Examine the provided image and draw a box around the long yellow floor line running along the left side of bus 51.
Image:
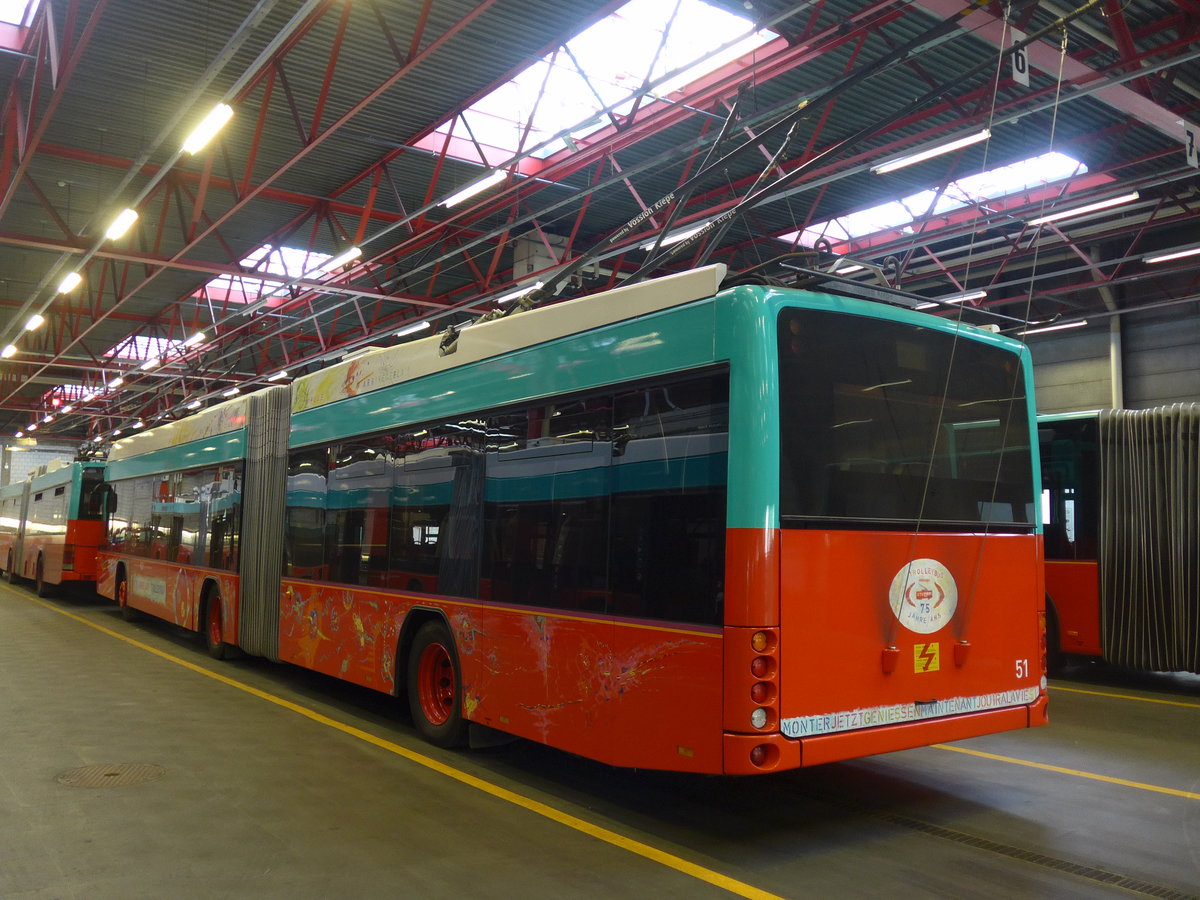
[23,592,782,900]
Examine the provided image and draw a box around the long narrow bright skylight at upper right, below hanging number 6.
[779,152,1087,253]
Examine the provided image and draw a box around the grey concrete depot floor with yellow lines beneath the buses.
[0,586,1200,900]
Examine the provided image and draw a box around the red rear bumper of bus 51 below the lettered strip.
[725,694,1049,775]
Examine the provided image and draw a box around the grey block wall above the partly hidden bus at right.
[1030,316,1200,413]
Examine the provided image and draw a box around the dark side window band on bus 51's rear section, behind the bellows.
[287,373,728,623]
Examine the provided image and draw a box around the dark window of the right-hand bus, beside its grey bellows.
[1038,419,1099,559]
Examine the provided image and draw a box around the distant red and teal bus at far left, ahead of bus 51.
[0,461,104,596]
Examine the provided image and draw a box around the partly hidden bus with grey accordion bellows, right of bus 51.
[1038,403,1200,673]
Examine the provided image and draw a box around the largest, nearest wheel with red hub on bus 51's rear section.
[407,619,467,748]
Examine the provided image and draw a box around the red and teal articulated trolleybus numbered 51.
[100,266,1046,773]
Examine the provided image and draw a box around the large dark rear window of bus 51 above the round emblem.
[779,310,1036,532]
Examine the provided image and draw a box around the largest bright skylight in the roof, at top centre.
[420,0,775,166]
